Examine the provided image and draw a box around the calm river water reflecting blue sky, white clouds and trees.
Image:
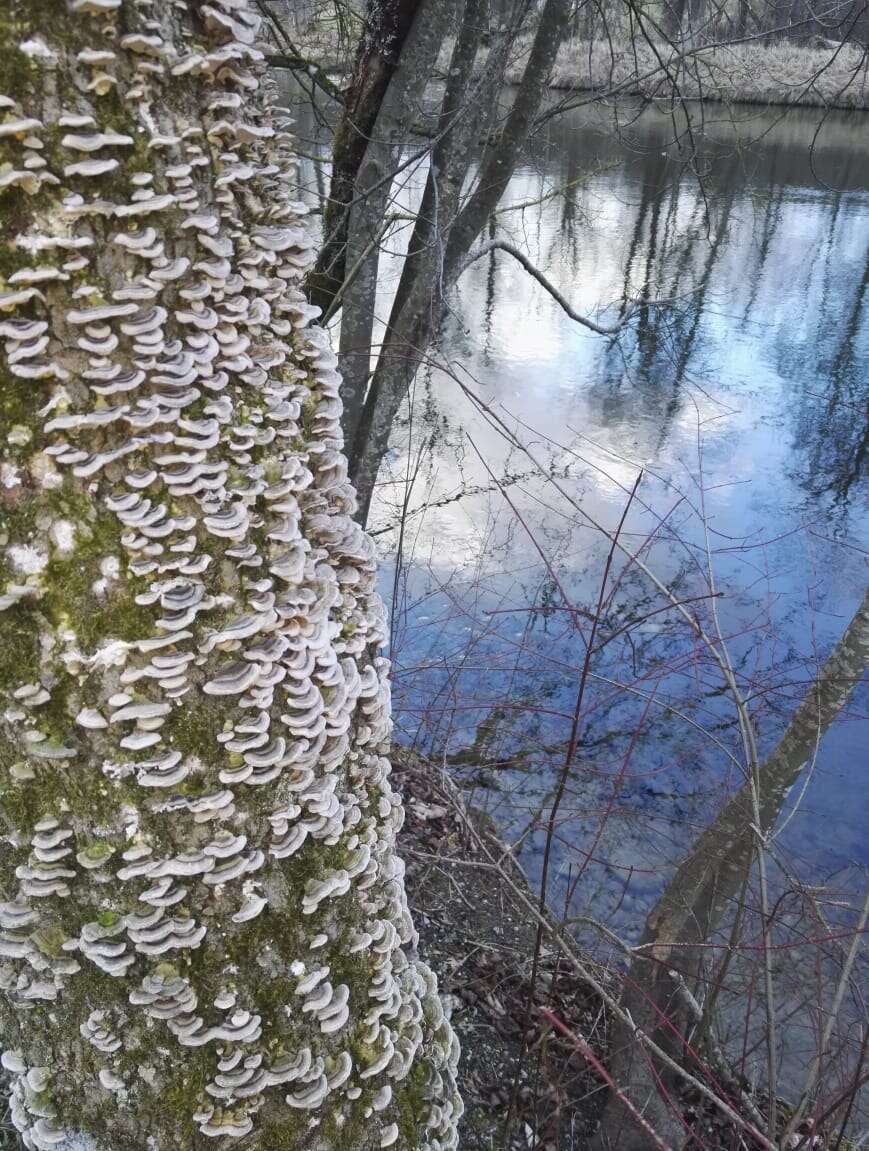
[281,78,869,1068]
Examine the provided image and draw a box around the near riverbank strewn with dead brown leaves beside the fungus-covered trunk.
[392,747,610,1151]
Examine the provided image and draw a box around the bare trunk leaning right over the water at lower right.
[596,592,869,1151]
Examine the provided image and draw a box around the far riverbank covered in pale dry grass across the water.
[269,37,869,110]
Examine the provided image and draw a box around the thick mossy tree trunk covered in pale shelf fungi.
[0,0,460,1151]
